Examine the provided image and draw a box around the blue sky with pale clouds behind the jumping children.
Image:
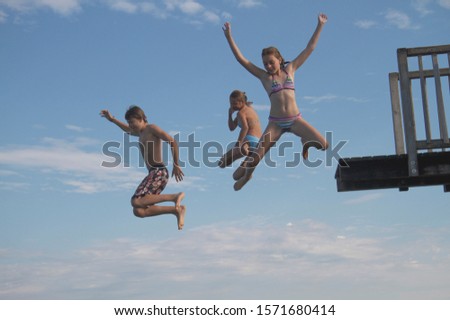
[0,0,450,299]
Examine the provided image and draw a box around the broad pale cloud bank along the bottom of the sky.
[0,220,450,299]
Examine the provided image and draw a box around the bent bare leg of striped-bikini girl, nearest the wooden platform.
[291,118,328,160]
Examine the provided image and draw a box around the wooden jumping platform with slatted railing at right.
[335,45,450,192]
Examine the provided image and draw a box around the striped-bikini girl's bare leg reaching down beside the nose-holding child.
[233,122,283,191]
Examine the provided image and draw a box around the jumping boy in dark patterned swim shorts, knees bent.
[100,106,186,230]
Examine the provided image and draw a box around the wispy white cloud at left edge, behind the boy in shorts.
[0,137,205,193]
